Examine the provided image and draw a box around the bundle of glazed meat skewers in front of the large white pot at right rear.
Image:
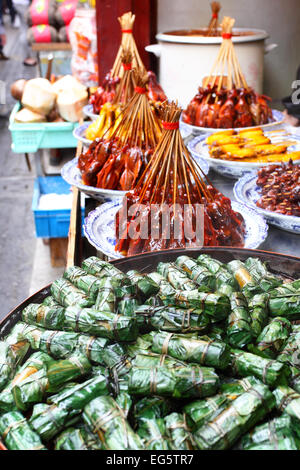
[183,16,274,129]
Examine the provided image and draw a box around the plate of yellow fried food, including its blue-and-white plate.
[188,128,300,179]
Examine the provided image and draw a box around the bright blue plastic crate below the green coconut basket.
[32,176,84,238]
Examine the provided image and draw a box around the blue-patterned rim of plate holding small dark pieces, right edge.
[233,171,300,224]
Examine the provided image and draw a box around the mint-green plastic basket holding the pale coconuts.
[8,103,78,153]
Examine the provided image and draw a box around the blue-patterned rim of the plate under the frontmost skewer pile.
[83,198,268,258]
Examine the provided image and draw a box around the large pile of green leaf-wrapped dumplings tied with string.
[0,254,300,450]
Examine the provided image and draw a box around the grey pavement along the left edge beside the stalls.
[0,6,62,319]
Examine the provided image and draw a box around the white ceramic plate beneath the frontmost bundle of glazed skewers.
[83,199,268,259]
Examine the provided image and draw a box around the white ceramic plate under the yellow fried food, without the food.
[187,134,300,179]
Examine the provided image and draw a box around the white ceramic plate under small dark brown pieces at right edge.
[233,172,300,234]
